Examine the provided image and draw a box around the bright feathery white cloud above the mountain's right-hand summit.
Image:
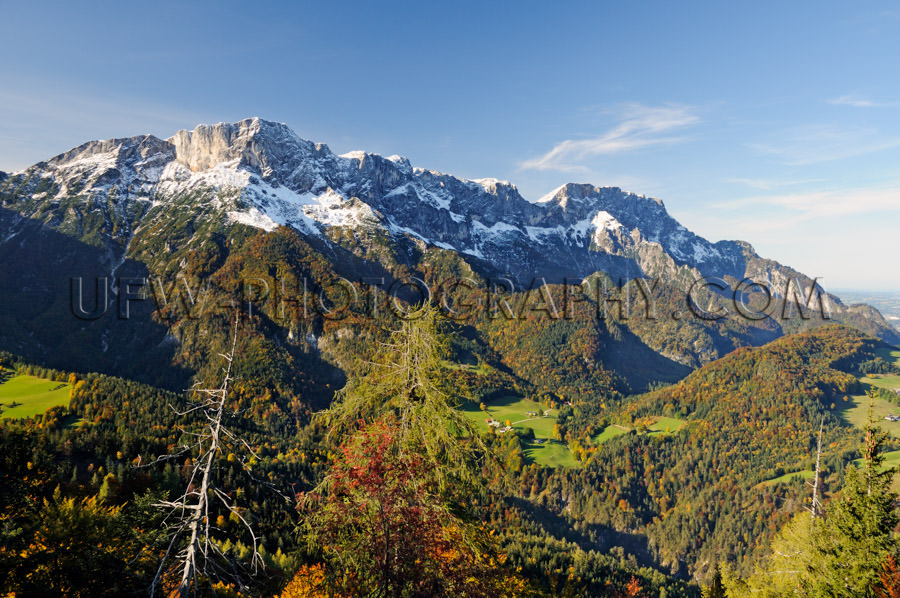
[519,104,700,172]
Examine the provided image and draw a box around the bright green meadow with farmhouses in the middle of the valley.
[463,397,578,467]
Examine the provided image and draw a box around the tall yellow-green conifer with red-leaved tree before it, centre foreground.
[301,306,525,596]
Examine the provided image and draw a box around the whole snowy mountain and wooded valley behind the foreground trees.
[0,118,900,597]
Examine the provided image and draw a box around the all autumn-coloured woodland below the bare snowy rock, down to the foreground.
[0,191,900,598]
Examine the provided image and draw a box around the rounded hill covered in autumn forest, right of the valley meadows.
[538,326,896,578]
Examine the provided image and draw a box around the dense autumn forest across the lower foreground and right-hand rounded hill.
[0,309,897,596]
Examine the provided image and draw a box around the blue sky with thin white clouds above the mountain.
[0,1,900,291]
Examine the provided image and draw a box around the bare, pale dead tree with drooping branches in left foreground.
[150,319,263,598]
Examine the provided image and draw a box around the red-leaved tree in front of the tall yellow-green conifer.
[308,418,458,596]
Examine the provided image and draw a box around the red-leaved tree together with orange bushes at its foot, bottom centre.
[298,416,527,597]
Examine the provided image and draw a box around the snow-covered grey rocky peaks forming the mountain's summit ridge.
[0,118,796,288]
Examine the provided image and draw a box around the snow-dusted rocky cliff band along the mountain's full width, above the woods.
[0,118,889,342]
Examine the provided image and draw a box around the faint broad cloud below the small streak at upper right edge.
[748,125,900,166]
